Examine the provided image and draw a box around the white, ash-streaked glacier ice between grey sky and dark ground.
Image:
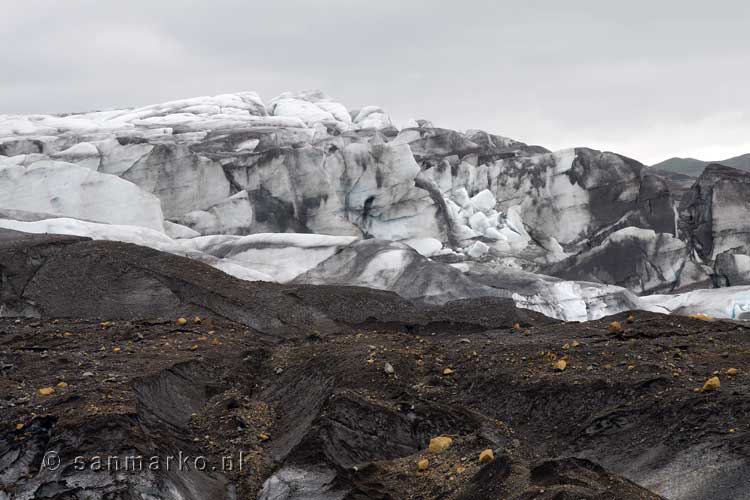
[0,91,750,321]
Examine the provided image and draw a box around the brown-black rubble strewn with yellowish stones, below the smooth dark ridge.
[5,306,750,500]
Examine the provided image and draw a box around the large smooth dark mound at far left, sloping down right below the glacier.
[0,232,325,333]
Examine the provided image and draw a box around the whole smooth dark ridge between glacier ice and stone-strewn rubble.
[0,231,547,335]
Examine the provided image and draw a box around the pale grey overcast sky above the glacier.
[0,0,750,163]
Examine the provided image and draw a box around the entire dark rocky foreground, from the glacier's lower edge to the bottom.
[0,232,750,500]
